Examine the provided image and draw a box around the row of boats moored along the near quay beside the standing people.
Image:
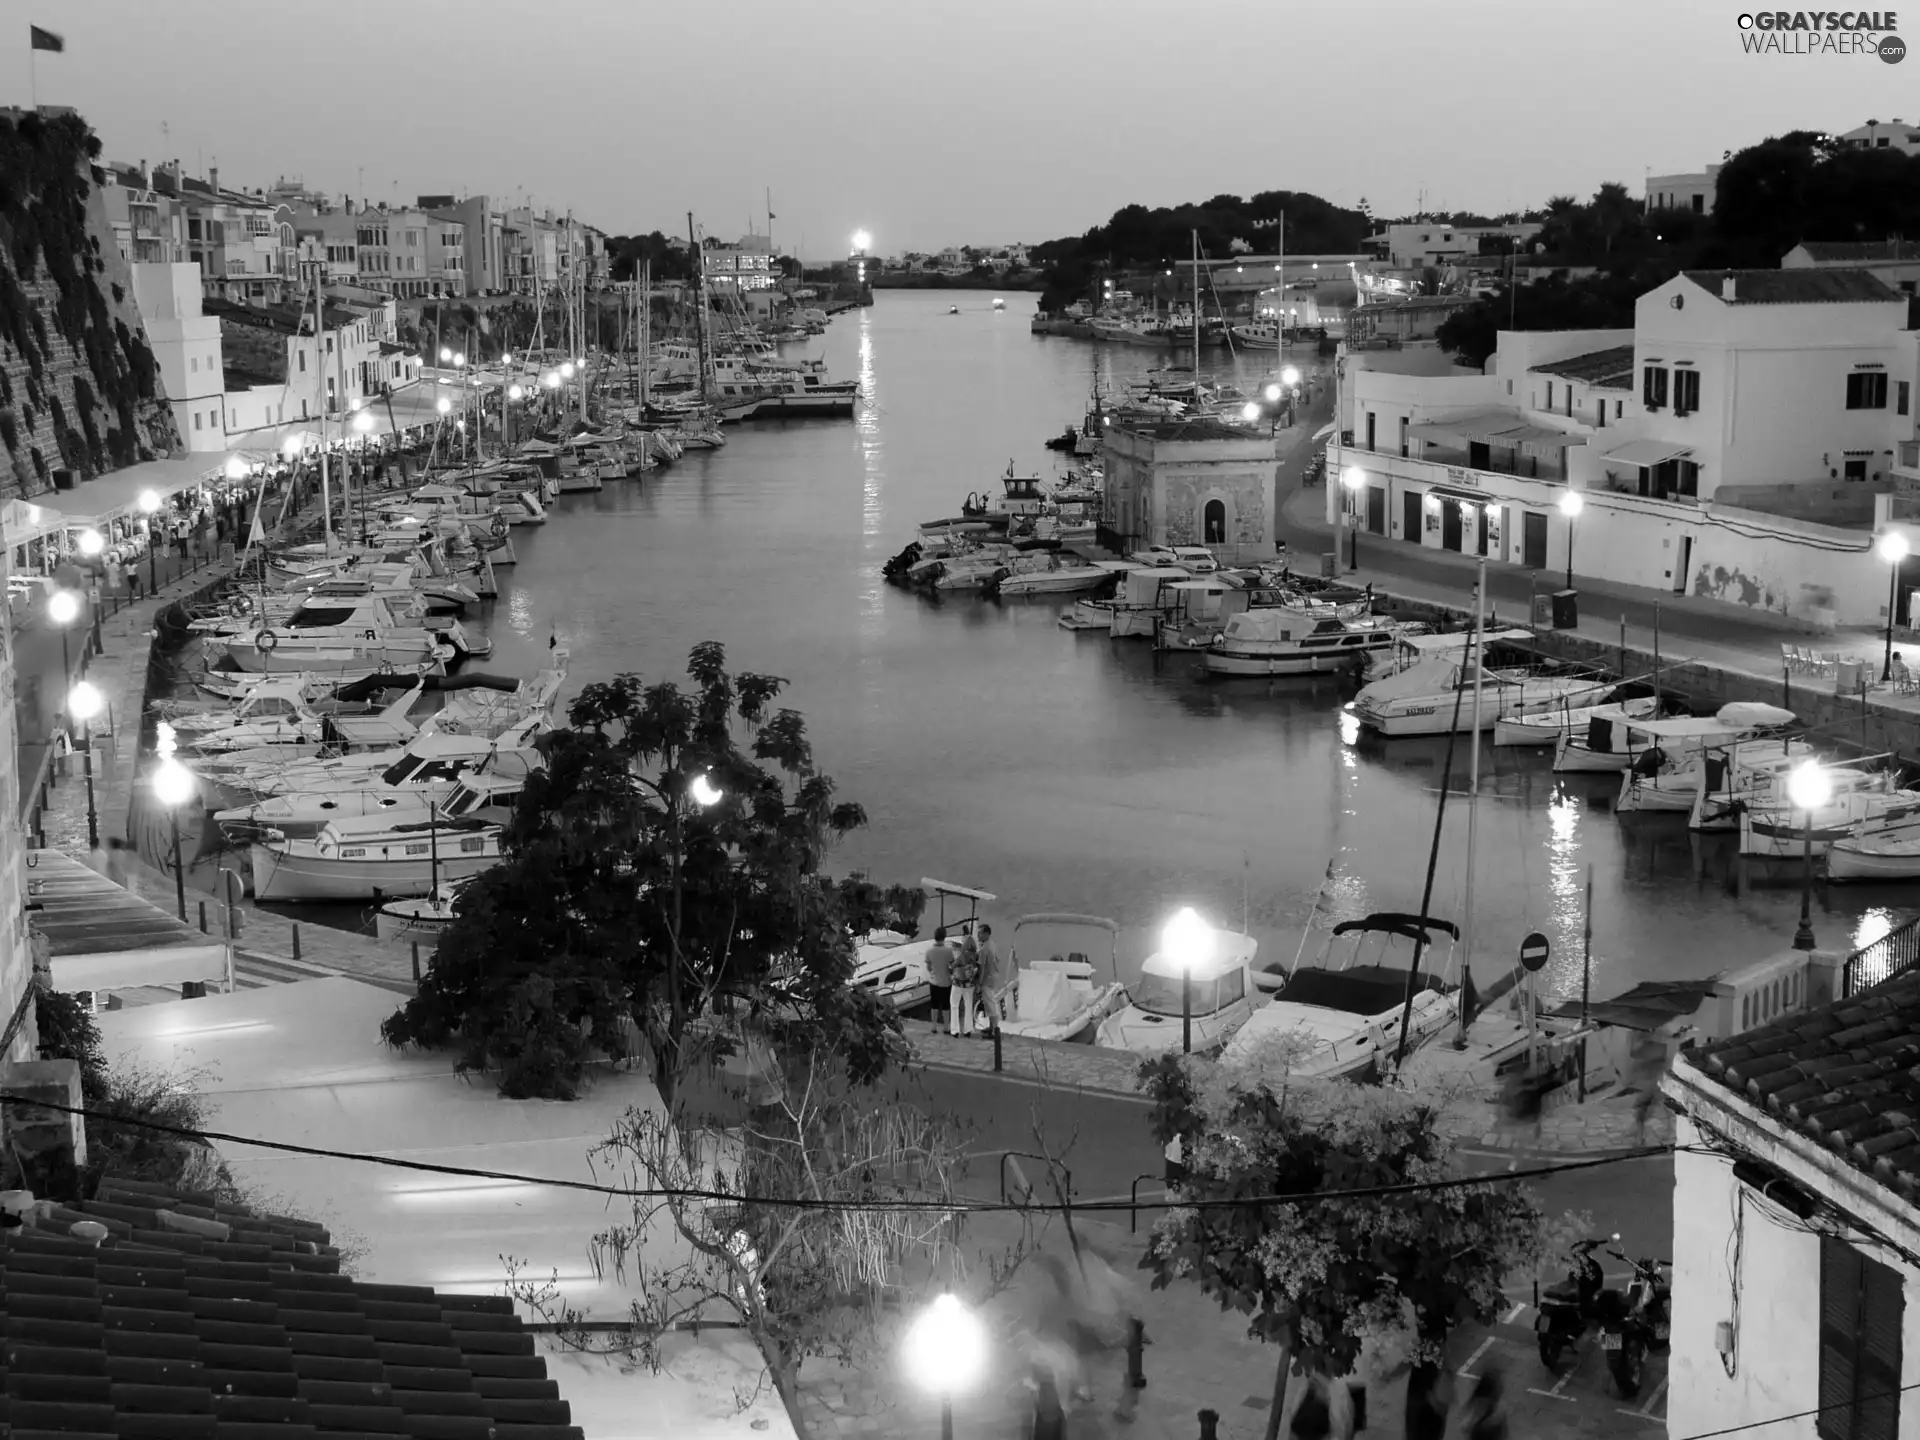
[854,879,1463,1079]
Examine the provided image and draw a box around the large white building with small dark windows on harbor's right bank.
[1327,269,1920,624]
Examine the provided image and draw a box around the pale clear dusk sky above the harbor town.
[15,0,1920,259]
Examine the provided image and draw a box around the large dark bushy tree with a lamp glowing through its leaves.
[382,641,900,1108]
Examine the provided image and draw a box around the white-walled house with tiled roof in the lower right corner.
[1661,952,1920,1440]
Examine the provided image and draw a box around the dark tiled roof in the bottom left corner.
[0,1181,582,1440]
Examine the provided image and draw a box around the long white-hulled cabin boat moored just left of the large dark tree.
[250,816,503,900]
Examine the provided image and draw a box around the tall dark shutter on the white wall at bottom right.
[1814,1236,1907,1440]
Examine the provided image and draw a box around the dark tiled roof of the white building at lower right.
[1693,970,1920,1202]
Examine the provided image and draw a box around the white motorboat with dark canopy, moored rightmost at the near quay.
[1221,914,1459,1079]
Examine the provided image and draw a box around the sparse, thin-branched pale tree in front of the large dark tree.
[509,1044,1025,1440]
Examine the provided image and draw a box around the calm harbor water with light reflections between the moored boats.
[274,292,1905,996]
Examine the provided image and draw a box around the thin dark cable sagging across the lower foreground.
[0,1092,1693,1215]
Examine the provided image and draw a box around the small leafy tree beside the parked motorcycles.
[1140,1056,1546,1440]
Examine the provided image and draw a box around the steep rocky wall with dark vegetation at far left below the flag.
[0,115,180,497]
